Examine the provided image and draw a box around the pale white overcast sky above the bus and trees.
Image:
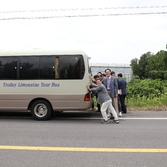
[0,0,167,64]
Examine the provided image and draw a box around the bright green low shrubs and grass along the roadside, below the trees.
[126,79,167,110]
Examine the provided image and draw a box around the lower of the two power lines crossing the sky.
[0,12,167,20]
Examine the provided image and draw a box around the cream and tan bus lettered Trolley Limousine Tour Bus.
[0,49,91,120]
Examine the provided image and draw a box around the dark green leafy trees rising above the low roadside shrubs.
[130,50,167,79]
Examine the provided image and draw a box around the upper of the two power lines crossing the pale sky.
[0,5,167,14]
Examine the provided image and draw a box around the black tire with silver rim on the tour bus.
[31,100,52,120]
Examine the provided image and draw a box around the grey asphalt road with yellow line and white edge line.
[0,111,167,167]
